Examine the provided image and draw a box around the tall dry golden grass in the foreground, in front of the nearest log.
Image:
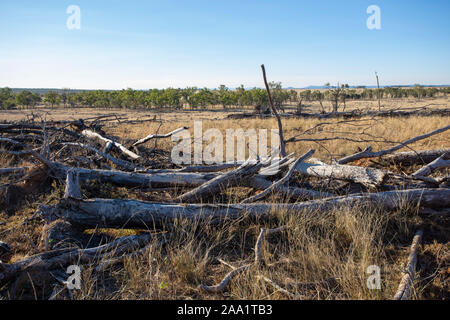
[67,202,428,299]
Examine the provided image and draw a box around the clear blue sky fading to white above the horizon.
[0,0,450,89]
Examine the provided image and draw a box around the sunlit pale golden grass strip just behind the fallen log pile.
[109,116,450,160]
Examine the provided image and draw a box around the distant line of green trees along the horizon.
[0,82,450,112]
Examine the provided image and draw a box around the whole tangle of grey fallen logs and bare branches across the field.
[0,110,450,298]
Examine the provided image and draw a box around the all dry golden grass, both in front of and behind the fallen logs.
[0,103,450,299]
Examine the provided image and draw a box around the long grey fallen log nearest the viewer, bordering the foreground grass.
[48,189,450,229]
